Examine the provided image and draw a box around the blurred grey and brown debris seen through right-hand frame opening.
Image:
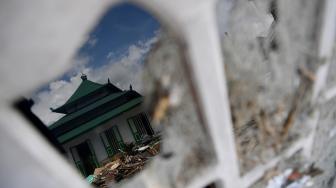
[218,0,322,173]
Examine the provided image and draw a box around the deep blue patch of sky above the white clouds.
[78,4,160,72]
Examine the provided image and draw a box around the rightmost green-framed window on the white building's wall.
[127,113,154,142]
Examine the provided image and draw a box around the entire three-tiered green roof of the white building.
[49,76,143,143]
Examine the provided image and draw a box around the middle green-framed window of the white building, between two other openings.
[100,125,125,157]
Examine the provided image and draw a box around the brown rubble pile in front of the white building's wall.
[87,138,160,187]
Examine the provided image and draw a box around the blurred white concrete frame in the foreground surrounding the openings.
[0,0,336,188]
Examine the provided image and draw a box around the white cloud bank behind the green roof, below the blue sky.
[32,36,157,125]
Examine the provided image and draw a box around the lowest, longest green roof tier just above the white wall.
[57,97,143,144]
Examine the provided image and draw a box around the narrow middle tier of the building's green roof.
[49,91,127,129]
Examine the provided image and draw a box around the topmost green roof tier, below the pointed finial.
[63,80,104,106]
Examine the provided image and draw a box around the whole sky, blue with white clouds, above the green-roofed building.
[32,4,160,125]
